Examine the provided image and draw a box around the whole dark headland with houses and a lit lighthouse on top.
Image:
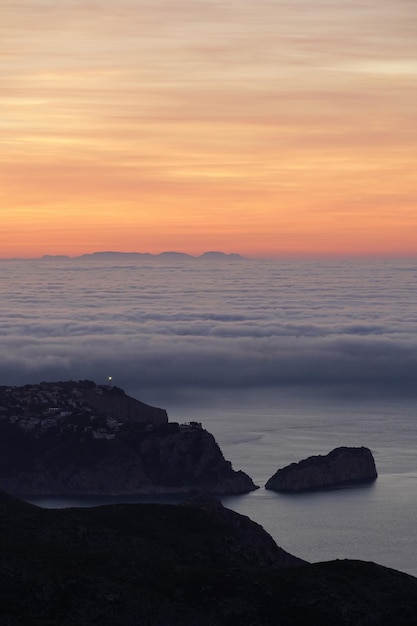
[0,380,257,497]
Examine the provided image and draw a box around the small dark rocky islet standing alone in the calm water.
[265,447,377,492]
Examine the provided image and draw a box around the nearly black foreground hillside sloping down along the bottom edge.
[0,495,417,626]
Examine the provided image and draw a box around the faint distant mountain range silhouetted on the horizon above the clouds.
[37,250,247,261]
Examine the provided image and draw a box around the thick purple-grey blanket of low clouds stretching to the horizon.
[0,255,417,398]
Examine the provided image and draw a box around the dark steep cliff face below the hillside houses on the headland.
[0,424,256,496]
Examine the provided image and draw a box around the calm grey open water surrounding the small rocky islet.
[169,389,417,575]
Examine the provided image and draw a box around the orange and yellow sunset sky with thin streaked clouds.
[0,0,417,258]
